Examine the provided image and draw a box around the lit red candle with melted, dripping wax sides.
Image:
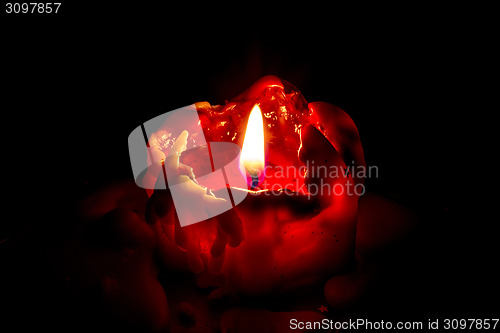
[140,76,364,296]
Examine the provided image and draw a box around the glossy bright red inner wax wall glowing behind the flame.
[193,76,309,192]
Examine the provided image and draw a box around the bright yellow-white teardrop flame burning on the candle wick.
[240,104,265,187]
